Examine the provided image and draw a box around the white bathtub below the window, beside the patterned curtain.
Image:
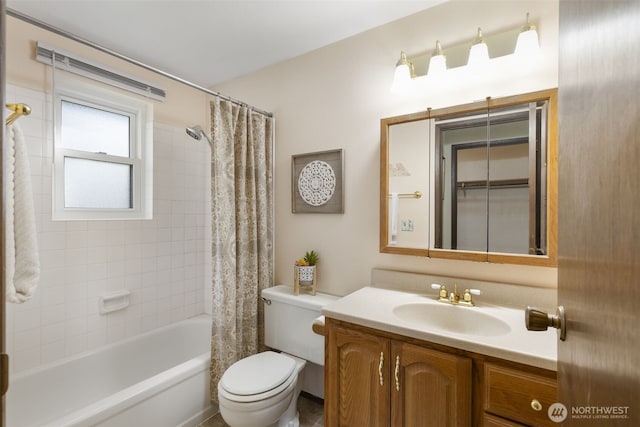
[6,316,217,427]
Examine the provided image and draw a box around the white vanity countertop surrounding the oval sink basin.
[322,287,558,371]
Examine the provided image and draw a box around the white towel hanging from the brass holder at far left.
[4,123,40,303]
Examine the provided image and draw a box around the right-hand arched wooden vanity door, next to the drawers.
[391,341,471,427]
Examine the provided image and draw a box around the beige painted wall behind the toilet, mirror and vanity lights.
[215,1,558,295]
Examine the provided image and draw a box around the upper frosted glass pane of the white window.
[61,101,130,157]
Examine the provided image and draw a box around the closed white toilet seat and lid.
[218,351,297,402]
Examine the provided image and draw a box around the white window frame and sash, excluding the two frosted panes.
[52,78,153,221]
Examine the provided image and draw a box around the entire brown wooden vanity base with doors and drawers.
[325,318,557,427]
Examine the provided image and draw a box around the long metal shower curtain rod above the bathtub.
[7,8,273,117]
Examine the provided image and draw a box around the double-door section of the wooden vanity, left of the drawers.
[325,321,472,427]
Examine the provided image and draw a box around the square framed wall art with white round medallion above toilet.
[291,149,344,213]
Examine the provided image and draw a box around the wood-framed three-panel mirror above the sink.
[380,90,557,266]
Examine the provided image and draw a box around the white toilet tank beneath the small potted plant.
[262,285,338,365]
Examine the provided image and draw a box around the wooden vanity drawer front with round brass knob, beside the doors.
[484,363,558,427]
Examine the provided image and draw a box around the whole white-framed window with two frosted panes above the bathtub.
[53,80,153,220]
